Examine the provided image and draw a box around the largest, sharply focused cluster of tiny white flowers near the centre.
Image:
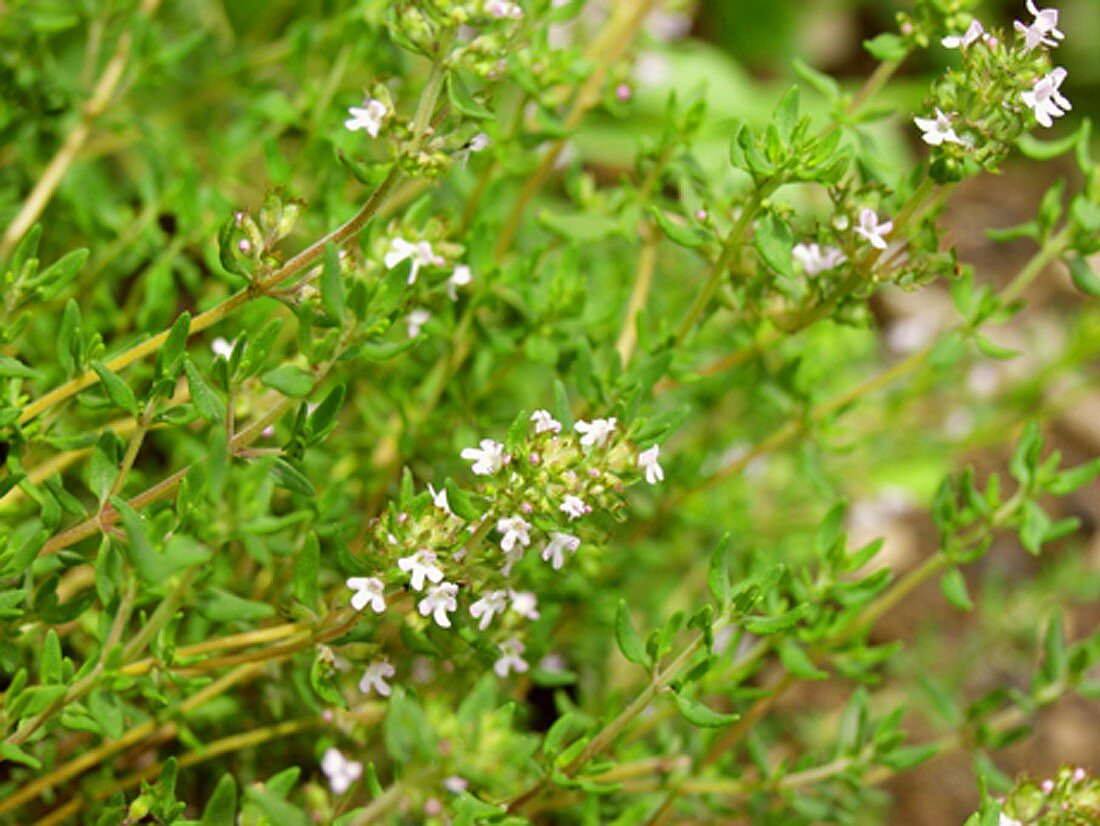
[330,411,664,695]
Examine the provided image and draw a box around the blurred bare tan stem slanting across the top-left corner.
[0,0,161,257]
